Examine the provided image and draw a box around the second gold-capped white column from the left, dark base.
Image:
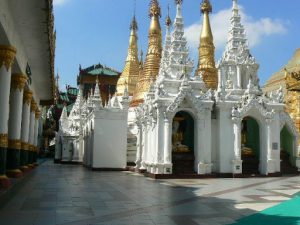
[6,74,27,178]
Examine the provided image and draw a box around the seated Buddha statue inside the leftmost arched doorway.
[172,117,190,153]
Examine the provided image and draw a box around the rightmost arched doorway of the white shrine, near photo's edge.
[280,126,298,174]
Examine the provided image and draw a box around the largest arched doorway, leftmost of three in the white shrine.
[172,111,195,174]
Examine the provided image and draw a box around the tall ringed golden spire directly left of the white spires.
[131,0,162,107]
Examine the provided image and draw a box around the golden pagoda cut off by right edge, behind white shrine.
[263,48,300,145]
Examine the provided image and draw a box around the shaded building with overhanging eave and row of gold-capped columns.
[0,0,55,188]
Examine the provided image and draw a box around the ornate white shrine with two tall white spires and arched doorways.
[136,1,300,175]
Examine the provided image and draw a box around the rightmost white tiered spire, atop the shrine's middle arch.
[218,0,259,92]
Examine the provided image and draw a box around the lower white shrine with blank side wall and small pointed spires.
[55,81,129,170]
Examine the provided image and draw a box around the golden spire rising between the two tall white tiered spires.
[197,0,218,89]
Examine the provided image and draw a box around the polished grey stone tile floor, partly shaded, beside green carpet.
[0,161,300,225]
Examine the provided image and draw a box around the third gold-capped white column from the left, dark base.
[20,90,32,171]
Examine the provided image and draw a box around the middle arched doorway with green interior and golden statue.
[241,117,260,174]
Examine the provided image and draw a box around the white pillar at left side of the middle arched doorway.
[232,118,243,174]
